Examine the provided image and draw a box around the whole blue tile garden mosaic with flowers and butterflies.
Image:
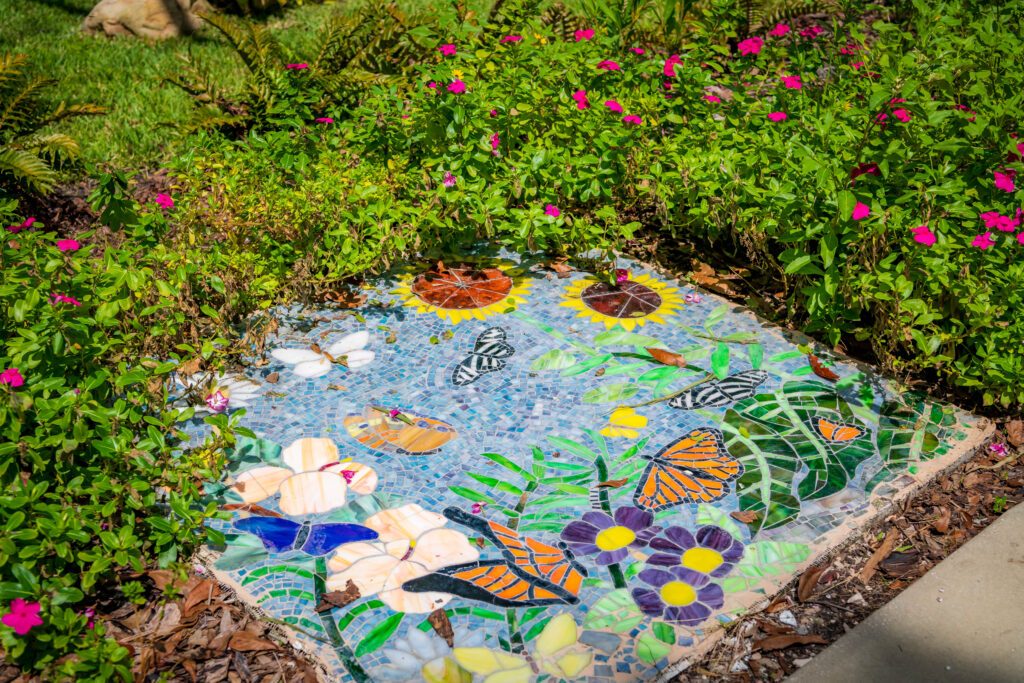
[180,255,981,683]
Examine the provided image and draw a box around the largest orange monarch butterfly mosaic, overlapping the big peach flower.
[401,508,587,607]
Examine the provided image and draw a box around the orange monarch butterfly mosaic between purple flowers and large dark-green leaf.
[633,427,743,512]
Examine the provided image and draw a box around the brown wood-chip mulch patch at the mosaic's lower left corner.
[0,570,323,683]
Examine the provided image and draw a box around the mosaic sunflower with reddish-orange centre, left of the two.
[391,261,529,325]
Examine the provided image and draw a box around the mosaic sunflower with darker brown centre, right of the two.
[559,273,683,331]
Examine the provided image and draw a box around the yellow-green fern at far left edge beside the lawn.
[0,52,103,194]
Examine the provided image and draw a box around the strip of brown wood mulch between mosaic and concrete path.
[675,419,1024,683]
